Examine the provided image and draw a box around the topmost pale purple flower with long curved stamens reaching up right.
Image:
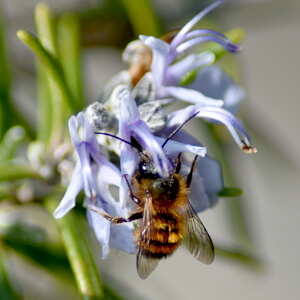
[140,1,240,106]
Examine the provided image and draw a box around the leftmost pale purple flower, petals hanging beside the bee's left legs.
[54,113,135,258]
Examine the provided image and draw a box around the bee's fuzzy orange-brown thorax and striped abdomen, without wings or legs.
[132,174,188,259]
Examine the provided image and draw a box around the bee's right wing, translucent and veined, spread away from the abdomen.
[186,201,215,265]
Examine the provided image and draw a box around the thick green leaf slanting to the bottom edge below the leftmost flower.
[45,197,105,299]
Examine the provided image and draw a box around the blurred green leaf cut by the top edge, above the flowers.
[123,0,162,36]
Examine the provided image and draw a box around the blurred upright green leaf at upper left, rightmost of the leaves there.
[57,13,84,111]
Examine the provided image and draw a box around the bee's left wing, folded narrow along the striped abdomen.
[136,197,159,279]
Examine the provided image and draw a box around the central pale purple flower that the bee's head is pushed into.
[115,88,224,212]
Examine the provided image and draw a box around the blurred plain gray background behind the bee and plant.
[2,0,300,300]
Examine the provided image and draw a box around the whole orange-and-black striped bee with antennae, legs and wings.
[95,113,214,279]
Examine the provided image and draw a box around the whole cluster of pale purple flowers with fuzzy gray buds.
[54,0,256,258]
